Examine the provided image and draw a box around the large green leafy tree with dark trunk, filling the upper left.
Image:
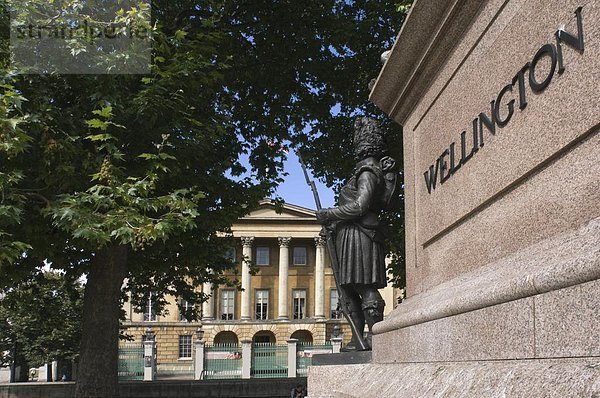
[0,0,402,397]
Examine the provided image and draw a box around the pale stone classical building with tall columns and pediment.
[125,200,394,366]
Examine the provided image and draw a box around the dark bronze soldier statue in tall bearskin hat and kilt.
[317,117,397,351]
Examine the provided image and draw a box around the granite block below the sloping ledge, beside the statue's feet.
[373,298,536,363]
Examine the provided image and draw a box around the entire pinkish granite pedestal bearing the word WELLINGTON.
[309,0,600,398]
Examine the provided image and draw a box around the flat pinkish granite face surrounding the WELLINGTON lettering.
[407,1,600,290]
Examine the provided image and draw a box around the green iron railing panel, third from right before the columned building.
[204,344,242,380]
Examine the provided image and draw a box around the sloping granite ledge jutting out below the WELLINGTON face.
[373,217,600,334]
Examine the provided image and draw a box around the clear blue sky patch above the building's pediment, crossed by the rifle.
[277,151,334,209]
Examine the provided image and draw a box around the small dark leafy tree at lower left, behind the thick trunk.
[0,272,83,380]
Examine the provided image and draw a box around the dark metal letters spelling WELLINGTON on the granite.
[424,7,583,194]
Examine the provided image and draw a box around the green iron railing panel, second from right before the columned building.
[250,343,288,378]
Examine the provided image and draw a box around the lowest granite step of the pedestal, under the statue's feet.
[308,358,600,398]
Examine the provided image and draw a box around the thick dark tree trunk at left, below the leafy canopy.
[75,246,127,398]
